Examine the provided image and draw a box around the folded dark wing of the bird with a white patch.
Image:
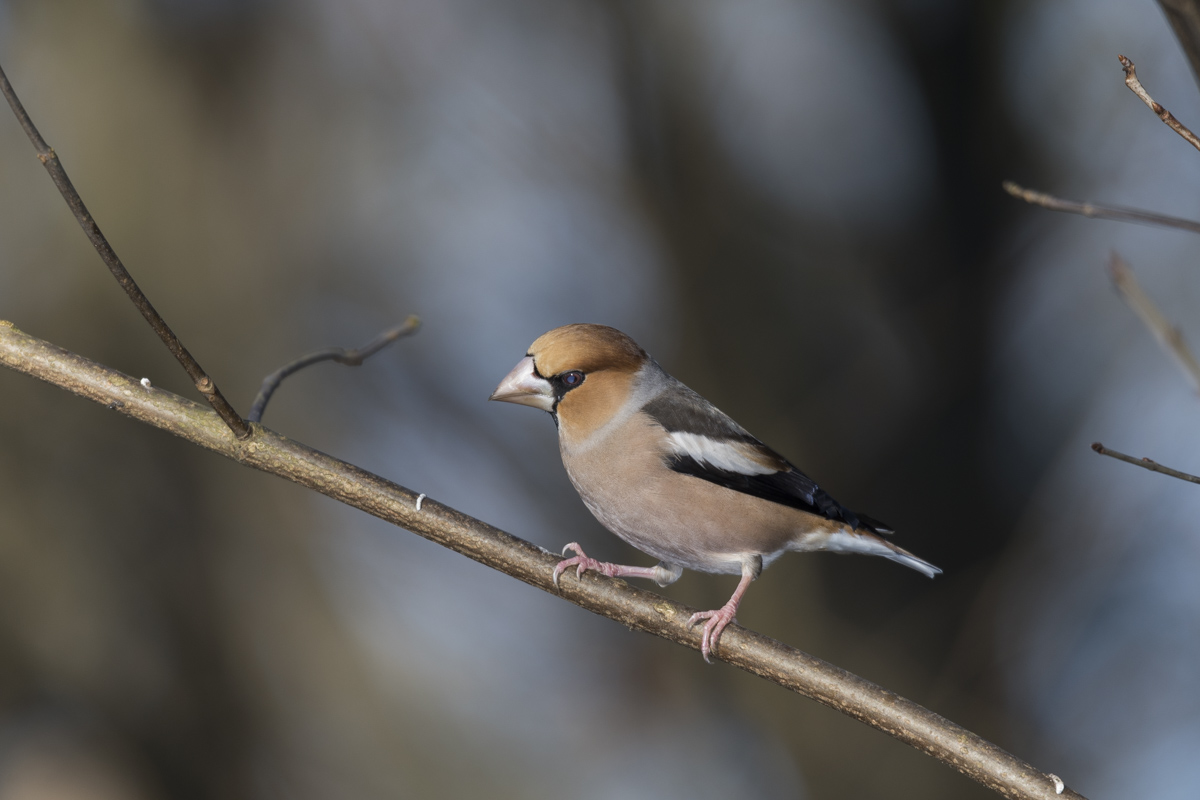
[643,381,892,534]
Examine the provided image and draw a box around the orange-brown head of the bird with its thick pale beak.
[488,324,649,433]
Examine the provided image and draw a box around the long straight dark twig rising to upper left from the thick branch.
[0,60,250,439]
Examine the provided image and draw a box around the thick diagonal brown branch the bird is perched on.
[0,321,1082,800]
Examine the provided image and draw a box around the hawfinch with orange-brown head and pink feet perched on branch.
[488,323,941,663]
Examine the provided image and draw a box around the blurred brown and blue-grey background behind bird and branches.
[0,0,1200,800]
